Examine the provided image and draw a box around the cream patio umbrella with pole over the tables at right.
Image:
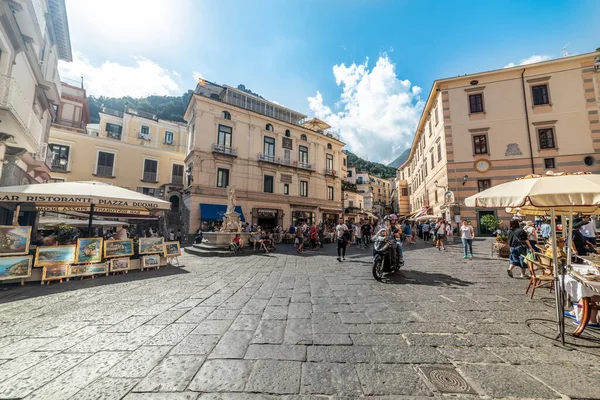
[465,172,600,345]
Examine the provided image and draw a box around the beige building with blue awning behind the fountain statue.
[184,83,346,233]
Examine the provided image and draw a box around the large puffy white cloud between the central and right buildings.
[308,54,424,163]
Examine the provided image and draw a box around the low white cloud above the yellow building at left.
[58,52,182,97]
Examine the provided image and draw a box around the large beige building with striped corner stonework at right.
[397,52,600,233]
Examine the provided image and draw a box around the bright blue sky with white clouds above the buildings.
[59,0,600,163]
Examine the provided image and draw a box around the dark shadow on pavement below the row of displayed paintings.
[0,265,189,304]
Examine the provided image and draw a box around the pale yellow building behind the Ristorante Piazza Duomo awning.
[48,83,187,229]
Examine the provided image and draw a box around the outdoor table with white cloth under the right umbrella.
[565,265,600,336]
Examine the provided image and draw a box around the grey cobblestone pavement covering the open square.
[0,240,600,400]
